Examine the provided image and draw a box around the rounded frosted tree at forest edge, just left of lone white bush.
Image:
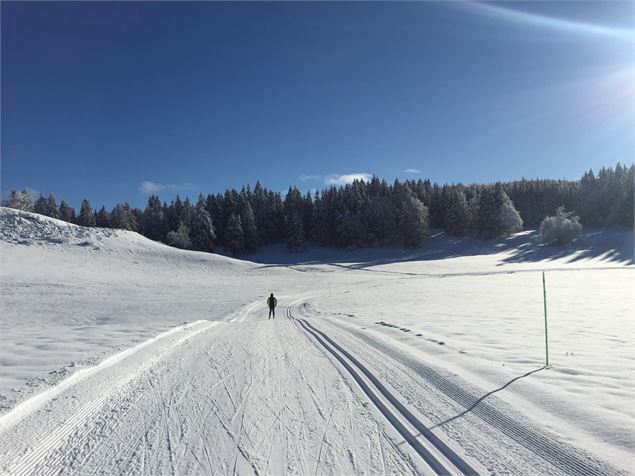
[478,183,523,238]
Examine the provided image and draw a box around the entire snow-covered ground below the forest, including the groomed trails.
[0,208,635,475]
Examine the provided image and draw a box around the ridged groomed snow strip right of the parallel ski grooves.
[288,298,626,476]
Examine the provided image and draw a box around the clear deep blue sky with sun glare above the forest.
[1,1,635,207]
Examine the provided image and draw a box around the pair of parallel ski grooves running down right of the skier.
[286,303,478,475]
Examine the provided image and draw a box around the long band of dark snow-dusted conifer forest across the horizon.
[4,163,635,256]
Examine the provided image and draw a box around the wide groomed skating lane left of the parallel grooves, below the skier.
[0,303,426,475]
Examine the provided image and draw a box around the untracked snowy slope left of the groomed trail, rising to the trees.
[0,207,296,411]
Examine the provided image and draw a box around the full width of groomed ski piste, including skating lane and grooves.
[0,297,620,475]
